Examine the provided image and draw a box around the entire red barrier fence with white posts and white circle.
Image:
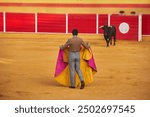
[0,12,150,41]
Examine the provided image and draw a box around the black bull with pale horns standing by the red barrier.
[100,25,116,47]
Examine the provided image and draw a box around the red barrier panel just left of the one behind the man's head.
[38,13,66,33]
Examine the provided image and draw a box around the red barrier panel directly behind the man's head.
[68,14,96,33]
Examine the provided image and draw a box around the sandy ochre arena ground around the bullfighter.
[0,34,150,100]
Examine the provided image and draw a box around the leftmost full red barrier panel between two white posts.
[6,13,35,32]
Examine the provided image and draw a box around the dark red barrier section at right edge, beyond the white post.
[142,14,150,35]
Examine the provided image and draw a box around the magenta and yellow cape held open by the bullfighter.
[54,48,97,87]
